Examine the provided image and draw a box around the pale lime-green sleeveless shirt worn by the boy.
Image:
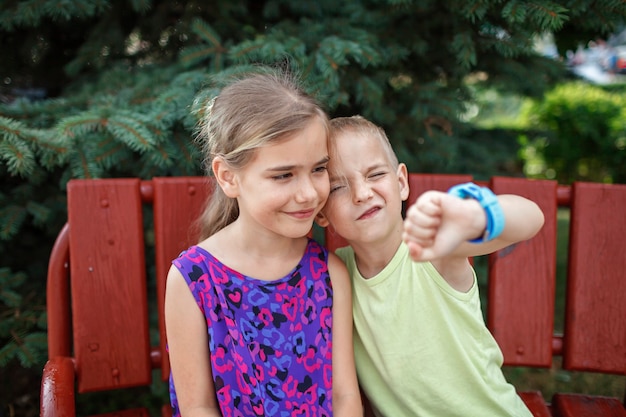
[337,243,532,417]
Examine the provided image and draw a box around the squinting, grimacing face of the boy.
[317,131,409,244]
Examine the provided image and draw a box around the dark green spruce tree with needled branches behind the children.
[0,0,626,415]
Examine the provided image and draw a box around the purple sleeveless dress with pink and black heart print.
[170,240,333,417]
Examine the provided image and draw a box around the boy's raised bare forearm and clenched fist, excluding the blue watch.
[403,191,544,261]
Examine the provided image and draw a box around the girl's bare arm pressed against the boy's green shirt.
[328,253,363,417]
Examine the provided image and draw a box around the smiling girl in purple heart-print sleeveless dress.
[165,72,362,417]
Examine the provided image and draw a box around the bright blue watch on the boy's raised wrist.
[448,182,505,243]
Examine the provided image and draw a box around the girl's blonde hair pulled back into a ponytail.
[197,70,329,240]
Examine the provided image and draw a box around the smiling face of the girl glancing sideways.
[229,118,330,238]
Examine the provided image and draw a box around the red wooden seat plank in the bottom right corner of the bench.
[552,394,626,417]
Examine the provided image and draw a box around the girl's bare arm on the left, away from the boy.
[165,266,221,417]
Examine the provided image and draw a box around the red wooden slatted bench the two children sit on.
[41,174,626,417]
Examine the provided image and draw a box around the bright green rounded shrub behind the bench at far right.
[521,82,626,184]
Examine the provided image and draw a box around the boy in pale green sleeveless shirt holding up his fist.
[317,116,544,417]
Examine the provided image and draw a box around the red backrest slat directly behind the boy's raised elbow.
[487,177,557,367]
